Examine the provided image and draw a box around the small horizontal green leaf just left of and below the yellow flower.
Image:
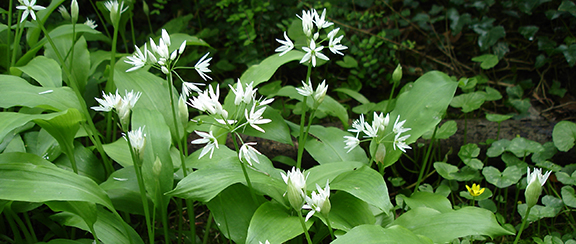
[397,191,452,213]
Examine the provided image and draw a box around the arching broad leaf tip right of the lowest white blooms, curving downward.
[330,166,393,213]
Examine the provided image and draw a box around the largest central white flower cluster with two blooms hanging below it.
[186,79,274,162]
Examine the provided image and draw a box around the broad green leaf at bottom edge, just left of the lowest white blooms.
[246,202,313,244]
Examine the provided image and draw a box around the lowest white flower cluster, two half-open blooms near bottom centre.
[281,168,331,221]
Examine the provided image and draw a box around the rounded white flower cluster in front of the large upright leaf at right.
[344,112,412,152]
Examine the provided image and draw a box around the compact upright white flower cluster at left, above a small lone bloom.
[92,90,142,129]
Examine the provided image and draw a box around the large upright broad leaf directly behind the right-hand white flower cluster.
[383,71,458,167]
